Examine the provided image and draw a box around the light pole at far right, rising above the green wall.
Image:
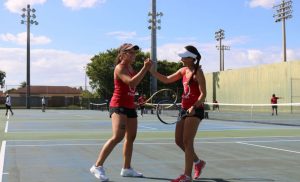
[273,0,293,62]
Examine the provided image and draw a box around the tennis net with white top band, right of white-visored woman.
[205,103,300,126]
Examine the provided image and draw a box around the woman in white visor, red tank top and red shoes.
[150,45,206,182]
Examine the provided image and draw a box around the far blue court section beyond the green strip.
[4,110,300,132]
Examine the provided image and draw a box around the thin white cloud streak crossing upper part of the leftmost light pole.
[0,32,51,45]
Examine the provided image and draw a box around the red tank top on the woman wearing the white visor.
[181,68,203,109]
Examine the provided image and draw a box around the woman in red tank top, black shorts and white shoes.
[90,43,152,181]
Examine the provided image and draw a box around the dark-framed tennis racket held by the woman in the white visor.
[156,100,188,125]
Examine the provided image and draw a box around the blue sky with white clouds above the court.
[0,0,300,88]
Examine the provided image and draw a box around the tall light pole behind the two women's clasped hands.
[148,0,163,94]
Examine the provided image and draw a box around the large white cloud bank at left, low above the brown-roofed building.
[0,48,92,87]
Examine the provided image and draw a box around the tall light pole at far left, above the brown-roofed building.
[21,4,38,109]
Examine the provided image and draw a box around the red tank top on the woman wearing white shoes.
[109,66,135,109]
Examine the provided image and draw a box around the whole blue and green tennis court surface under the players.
[0,110,300,182]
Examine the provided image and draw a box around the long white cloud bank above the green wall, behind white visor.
[154,38,300,73]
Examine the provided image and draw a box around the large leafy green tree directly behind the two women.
[86,49,182,99]
